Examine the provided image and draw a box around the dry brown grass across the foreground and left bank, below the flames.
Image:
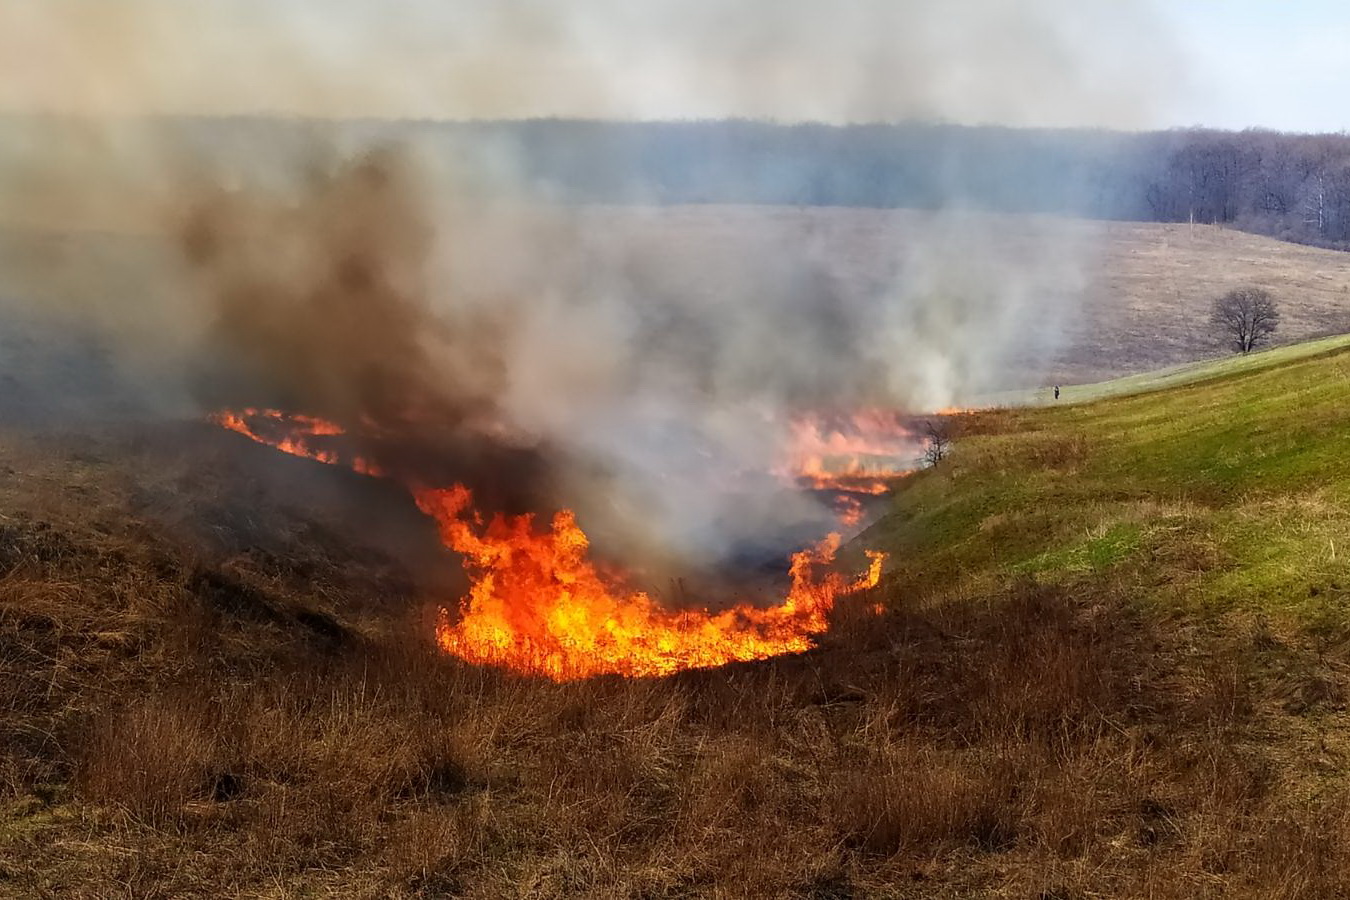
[0,426,1350,899]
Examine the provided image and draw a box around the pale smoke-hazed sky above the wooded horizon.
[0,0,1350,131]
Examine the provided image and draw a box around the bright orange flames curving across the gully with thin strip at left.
[212,410,886,681]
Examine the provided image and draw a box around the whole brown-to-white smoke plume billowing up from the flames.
[168,152,1081,565]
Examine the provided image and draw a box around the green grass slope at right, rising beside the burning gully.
[867,337,1350,625]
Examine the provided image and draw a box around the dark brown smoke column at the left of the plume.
[180,150,549,513]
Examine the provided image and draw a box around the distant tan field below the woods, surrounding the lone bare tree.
[569,206,1350,389]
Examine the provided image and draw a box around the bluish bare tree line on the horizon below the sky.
[431,119,1350,248]
